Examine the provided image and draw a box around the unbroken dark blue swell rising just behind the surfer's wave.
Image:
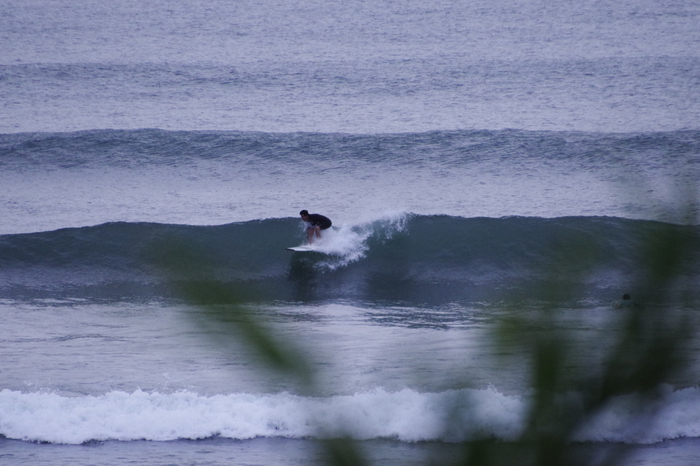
[0,129,700,171]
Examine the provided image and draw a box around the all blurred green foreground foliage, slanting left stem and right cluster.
[154,187,698,466]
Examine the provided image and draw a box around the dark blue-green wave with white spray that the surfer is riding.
[0,214,700,304]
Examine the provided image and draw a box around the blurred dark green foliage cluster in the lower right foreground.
[468,189,699,466]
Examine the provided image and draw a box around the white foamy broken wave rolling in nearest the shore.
[0,387,700,444]
